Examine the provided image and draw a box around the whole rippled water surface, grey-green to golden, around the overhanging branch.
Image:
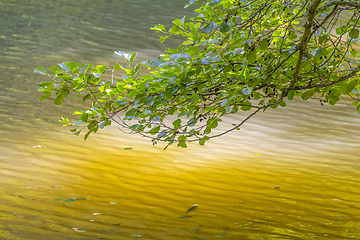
[0,0,360,239]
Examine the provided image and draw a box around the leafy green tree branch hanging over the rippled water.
[35,0,360,147]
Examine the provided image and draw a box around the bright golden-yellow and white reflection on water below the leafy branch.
[0,101,360,239]
